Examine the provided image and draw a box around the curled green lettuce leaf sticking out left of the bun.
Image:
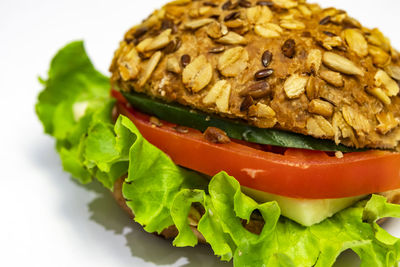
[36,42,128,189]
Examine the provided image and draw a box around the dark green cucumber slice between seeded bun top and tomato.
[122,92,363,152]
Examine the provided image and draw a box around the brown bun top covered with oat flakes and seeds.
[110,0,400,149]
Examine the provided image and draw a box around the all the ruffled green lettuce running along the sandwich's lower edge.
[36,42,400,267]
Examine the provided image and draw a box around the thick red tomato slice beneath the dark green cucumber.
[117,94,400,199]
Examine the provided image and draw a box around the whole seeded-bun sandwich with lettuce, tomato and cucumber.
[36,0,400,266]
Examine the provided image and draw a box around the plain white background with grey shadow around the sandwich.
[0,0,400,267]
